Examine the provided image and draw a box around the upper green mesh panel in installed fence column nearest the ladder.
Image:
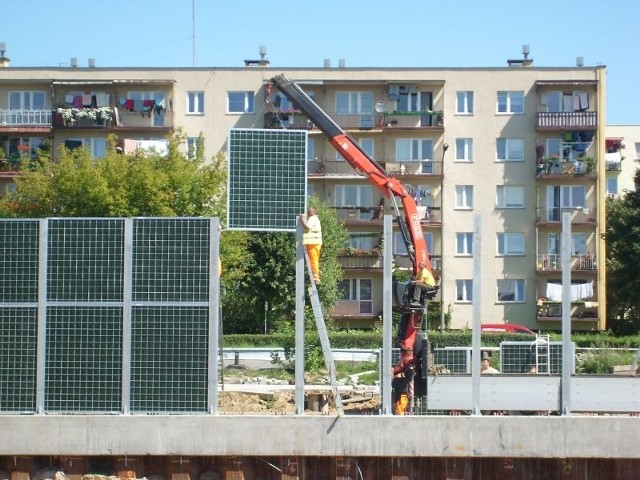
[132,218,210,302]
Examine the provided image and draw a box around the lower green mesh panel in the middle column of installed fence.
[45,307,122,412]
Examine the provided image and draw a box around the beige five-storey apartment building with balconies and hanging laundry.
[0,57,613,330]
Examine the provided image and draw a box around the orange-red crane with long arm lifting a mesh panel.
[266,75,437,414]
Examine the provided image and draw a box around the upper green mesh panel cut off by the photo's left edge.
[0,220,40,303]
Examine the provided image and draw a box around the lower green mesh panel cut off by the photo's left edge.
[0,307,38,412]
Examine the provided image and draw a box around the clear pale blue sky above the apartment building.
[0,0,640,125]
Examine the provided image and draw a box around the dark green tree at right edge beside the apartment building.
[604,171,640,334]
